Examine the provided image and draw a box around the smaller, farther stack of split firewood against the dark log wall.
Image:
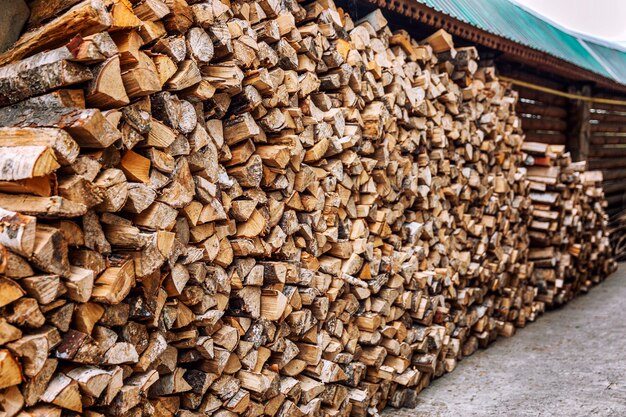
[523,142,615,305]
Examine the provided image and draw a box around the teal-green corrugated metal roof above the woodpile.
[417,0,626,85]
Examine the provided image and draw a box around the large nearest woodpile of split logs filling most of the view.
[0,0,616,417]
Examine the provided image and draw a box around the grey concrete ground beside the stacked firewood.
[385,263,626,417]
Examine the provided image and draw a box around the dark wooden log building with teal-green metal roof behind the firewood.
[342,0,626,217]
